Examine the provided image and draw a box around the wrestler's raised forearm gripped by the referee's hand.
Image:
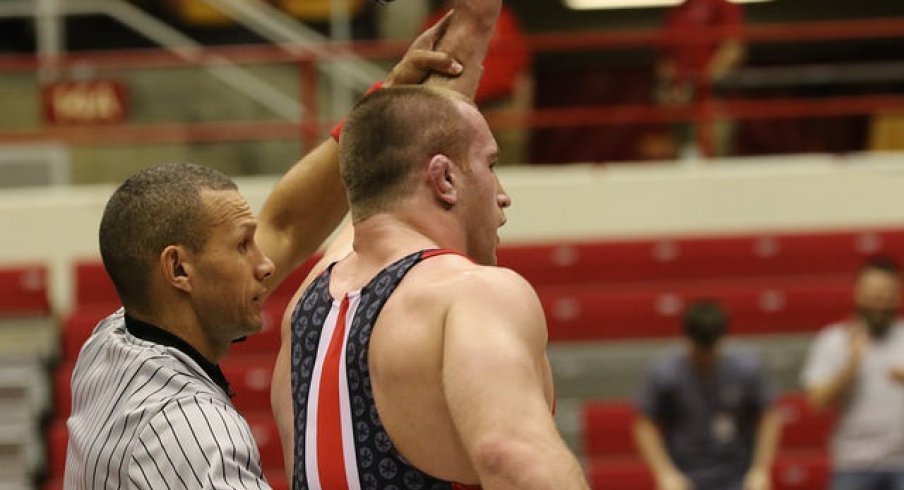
[424,0,502,99]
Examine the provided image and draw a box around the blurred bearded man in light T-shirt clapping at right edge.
[801,258,904,490]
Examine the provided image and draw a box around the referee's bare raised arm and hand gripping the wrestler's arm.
[254,12,462,291]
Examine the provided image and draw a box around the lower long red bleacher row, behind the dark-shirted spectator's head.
[538,276,852,341]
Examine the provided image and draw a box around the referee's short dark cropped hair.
[99,163,237,308]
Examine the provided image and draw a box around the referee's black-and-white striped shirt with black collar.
[64,310,270,490]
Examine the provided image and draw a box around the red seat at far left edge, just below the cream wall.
[0,264,50,317]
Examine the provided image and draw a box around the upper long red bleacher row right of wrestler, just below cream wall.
[498,230,904,287]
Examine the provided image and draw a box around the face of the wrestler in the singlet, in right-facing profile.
[458,103,511,265]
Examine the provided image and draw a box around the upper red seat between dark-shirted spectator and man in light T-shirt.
[778,393,837,451]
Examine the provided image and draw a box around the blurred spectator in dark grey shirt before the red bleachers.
[634,301,781,490]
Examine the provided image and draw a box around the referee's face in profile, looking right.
[191,190,273,345]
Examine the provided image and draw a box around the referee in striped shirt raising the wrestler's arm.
[64,22,461,490]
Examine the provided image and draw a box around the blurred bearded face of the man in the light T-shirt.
[854,269,901,335]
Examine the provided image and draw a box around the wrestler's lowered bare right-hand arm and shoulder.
[442,267,588,490]
